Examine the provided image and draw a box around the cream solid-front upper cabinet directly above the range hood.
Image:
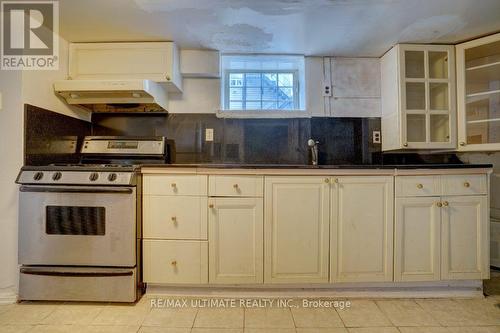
[69,42,182,92]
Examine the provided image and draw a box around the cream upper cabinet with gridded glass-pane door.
[381,44,456,151]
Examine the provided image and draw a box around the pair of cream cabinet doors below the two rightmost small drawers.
[394,179,489,281]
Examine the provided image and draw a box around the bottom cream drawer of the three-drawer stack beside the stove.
[143,240,208,284]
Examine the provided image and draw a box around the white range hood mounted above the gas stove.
[54,79,168,112]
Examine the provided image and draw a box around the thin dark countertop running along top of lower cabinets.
[141,163,493,170]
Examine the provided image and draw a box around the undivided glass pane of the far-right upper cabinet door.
[461,41,500,145]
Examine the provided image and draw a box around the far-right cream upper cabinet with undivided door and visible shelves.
[456,33,500,151]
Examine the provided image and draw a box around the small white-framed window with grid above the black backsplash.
[221,55,304,112]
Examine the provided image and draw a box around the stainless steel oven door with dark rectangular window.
[19,186,136,267]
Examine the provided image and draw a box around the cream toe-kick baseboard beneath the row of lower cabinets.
[146,280,484,299]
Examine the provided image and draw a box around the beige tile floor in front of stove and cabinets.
[0,296,500,333]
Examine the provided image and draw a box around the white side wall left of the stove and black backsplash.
[0,34,89,303]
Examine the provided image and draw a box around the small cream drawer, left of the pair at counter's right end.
[396,176,441,197]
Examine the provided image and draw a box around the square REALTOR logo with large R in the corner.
[1,1,59,70]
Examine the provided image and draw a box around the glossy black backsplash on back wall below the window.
[92,113,380,164]
